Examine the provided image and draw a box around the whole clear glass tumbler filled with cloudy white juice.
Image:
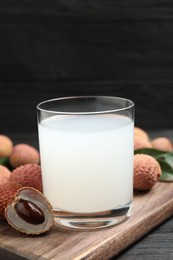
[37,96,134,230]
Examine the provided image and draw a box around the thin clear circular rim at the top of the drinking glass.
[36,95,135,115]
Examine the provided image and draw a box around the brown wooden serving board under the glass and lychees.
[0,183,173,260]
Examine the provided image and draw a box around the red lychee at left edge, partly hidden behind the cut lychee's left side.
[0,182,21,219]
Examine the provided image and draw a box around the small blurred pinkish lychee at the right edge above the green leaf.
[151,137,173,152]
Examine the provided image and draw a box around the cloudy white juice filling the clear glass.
[39,115,133,213]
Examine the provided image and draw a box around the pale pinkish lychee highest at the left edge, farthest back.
[0,135,13,158]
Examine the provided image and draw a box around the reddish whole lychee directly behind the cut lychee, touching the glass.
[9,164,43,192]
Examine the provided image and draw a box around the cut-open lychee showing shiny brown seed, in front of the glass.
[5,187,54,235]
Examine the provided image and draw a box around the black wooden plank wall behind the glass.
[0,0,173,136]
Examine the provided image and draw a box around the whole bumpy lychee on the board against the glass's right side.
[133,154,162,191]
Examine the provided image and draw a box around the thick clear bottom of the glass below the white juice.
[54,202,132,231]
